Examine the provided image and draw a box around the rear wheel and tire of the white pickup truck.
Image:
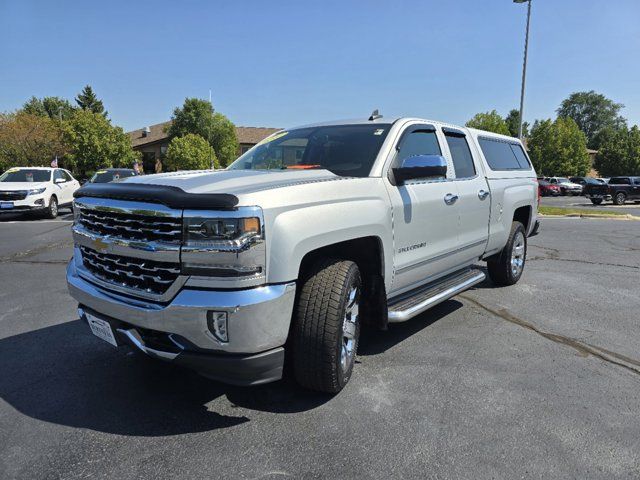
[487,222,527,286]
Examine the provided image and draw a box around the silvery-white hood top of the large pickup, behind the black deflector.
[125,170,343,195]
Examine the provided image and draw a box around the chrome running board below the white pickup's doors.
[388,269,485,323]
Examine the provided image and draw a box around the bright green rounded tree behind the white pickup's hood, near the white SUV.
[63,110,139,175]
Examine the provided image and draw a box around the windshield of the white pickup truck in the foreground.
[228,124,391,177]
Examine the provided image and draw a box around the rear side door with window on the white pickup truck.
[442,127,491,261]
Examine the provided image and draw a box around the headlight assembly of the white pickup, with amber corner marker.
[181,207,266,280]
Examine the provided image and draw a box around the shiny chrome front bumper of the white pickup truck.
[67,259,295,384]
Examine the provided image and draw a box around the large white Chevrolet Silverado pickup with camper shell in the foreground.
[67,115,538,392]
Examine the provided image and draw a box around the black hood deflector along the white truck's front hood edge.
[73,182,238,210]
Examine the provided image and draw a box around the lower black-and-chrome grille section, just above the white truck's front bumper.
[80,246,180,295]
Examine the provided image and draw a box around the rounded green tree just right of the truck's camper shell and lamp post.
[527,117,591,176]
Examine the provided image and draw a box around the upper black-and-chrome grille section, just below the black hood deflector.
[78,207,182,244]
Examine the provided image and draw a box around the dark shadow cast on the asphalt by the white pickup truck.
[0,301,461,437]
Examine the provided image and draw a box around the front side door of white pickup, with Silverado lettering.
[387,124,459,295]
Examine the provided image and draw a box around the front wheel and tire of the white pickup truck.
[292,259,362,393]
